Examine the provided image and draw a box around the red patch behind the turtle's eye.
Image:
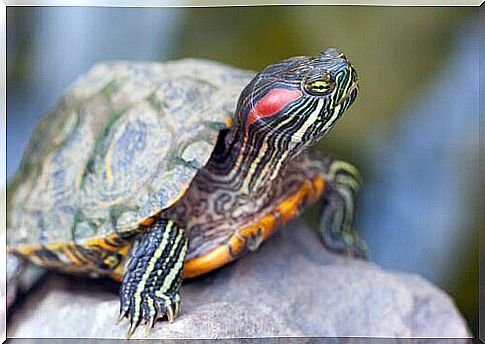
[246,88,301,131]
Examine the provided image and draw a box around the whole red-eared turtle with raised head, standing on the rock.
[7,48,367,336]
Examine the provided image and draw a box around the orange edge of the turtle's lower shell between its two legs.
[183,176,325,278]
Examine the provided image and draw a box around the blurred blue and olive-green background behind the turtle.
[2,6,478,333]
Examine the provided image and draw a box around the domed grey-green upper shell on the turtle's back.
[7,59,254,246]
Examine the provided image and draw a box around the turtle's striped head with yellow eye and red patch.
[236,48,358,155]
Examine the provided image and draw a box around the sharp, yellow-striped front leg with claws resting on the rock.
[120,219,187,336]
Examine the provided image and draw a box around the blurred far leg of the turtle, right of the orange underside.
[320,159,368,259]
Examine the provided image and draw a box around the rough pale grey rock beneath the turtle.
[8,221,470,338]
